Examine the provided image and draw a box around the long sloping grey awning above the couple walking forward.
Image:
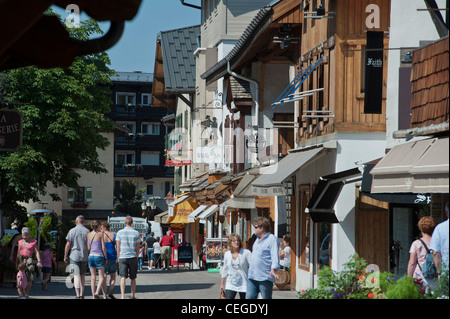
[252,147,326,196]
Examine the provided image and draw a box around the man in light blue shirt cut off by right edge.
[430,202,449,274]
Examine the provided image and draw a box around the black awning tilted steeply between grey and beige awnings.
[305,168,362,223]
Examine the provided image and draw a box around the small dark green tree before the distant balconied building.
[114,179,143,217]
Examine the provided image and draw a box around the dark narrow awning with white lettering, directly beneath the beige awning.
[360,160,431,205]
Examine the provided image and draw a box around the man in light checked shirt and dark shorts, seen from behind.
[116,216,141,299]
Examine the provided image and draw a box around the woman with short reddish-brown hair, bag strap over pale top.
[407,216,436,287]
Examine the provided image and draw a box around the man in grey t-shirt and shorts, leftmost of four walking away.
[64,215,89,299]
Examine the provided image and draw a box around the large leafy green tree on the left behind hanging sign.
[0,12,115,208]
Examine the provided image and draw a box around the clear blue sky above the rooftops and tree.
[55,0,201,72]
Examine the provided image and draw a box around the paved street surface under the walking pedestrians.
[0,267,297,299]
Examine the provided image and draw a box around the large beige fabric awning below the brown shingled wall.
[370,137,449,193]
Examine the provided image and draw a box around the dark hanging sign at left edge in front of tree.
[0,109,23,151]
